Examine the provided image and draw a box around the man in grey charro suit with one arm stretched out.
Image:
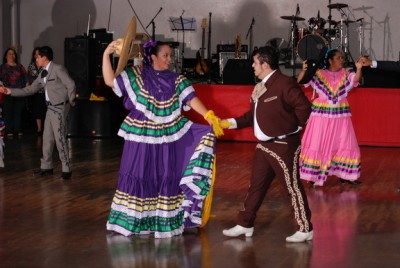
[0,46,75,179]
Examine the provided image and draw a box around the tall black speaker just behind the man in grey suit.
[64,36,95,100]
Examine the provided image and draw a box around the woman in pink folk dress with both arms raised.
[297,49,362,186]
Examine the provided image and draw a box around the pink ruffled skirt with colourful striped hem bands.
[300,116,361,185]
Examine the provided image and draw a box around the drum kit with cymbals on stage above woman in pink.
[276,1,362,76]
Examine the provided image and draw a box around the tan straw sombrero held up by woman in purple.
[115,17,149,76]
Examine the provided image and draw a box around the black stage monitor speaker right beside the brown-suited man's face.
[222,59,255,85]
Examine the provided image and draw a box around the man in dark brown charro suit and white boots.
[223,47,313,242]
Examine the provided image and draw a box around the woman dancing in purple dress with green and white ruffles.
[103,40,222,238]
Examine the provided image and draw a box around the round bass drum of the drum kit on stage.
[297,34,328,61]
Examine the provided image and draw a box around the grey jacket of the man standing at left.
[11,62,75,105]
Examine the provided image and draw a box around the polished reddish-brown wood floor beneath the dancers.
[0,134,400,268]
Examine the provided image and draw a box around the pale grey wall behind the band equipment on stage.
[8,0,400,65]
